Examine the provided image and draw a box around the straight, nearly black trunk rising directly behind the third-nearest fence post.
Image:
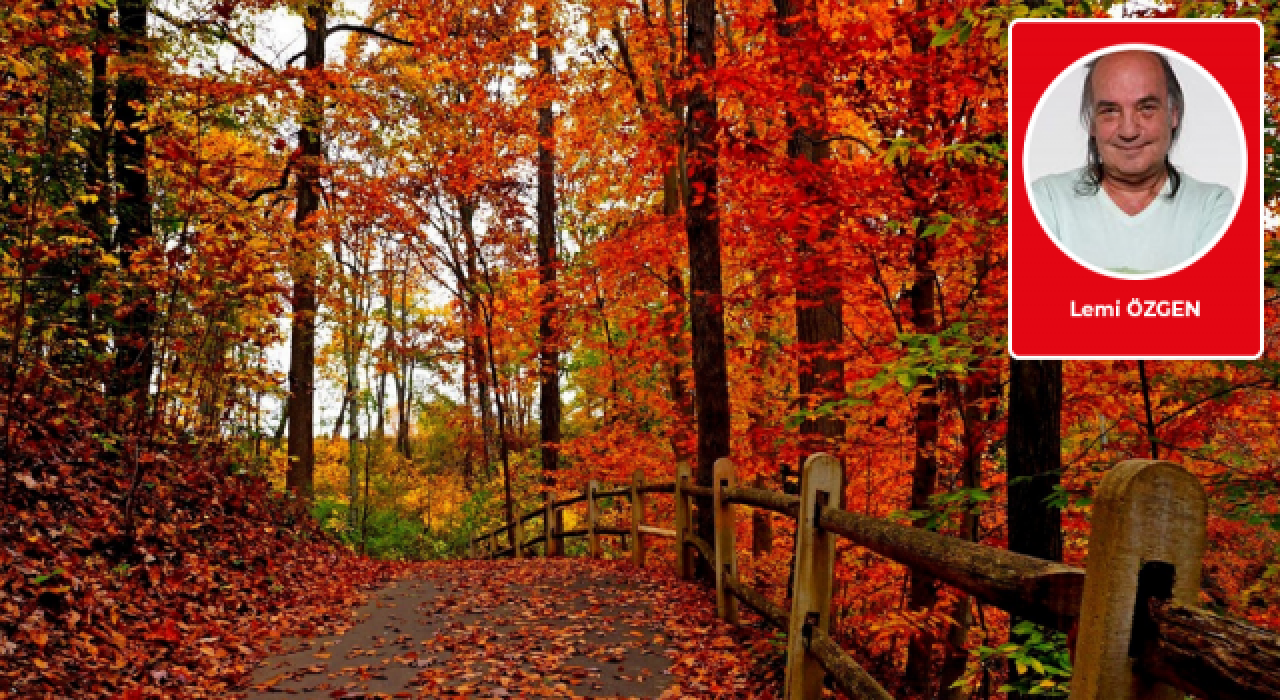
[685,0,730,578]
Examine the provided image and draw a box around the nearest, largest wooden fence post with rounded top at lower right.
[1071,459,1208,700]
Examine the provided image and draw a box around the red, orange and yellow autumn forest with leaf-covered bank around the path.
[0,0,1280,700]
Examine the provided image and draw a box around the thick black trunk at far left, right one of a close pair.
[109,0,155,404]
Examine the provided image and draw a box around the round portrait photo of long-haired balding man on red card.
[1024,45,1244,279]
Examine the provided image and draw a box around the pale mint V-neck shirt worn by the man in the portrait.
[1032,168,1235,274]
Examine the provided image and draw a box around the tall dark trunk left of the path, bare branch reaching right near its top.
[285,1,328,503]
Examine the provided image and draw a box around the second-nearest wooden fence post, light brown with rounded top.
[783,452,844,700]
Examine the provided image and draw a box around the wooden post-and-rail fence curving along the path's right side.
[471,453,1280,700]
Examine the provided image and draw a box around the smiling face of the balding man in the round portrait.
[1093,51,1180,182]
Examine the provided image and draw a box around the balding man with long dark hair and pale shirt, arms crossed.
[1032,51,1234,274]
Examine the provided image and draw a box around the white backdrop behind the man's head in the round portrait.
[1015,45,1244,200]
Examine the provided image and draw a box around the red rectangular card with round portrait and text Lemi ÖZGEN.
[1009,19,1263,360]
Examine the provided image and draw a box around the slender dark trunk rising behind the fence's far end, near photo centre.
[538,0,561,489]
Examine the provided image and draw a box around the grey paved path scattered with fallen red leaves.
[240,558,781,700]
